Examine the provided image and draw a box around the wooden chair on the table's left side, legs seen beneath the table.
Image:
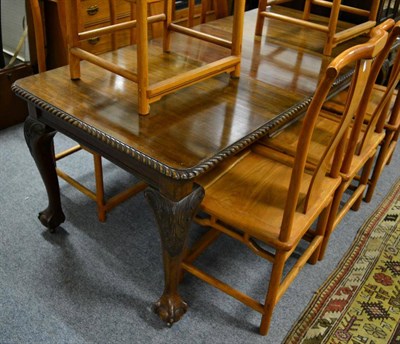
[30,0,147,222]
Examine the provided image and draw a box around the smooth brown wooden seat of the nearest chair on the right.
[197,147,340,250]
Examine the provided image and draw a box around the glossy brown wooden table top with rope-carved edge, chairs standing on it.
[13,11,356,180]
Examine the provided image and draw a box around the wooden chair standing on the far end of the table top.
[256,0,379,56]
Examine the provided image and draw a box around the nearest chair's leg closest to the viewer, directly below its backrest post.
[260,251,287,336]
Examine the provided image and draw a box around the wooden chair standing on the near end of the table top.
[65,0,245,115]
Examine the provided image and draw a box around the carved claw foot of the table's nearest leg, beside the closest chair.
[153,296,188,327]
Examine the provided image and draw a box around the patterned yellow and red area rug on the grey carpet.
[284,180,400,344]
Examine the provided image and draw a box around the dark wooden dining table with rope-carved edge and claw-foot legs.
[12,9,355,325]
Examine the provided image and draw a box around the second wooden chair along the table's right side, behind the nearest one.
[260,19,400,259]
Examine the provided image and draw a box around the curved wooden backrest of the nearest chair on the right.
[280,23,388,241]
